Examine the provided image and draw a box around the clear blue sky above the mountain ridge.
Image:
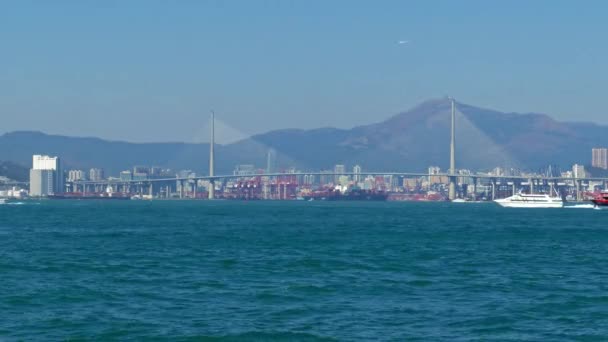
[0,0,608,141]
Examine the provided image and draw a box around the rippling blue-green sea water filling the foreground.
[0,201,608,341]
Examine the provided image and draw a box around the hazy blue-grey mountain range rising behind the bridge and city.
[0,98,608,175]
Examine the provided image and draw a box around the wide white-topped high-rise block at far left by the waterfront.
[30,155,65,196]
